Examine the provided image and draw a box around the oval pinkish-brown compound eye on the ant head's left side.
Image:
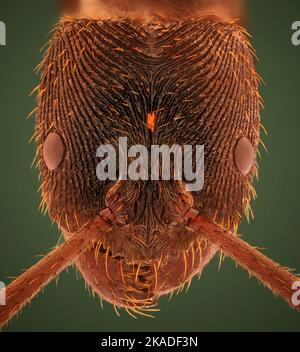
[43,132,65,171]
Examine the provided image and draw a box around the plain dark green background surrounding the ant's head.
[0,0,300,331]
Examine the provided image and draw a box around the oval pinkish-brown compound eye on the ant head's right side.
[234,137,255,176]
